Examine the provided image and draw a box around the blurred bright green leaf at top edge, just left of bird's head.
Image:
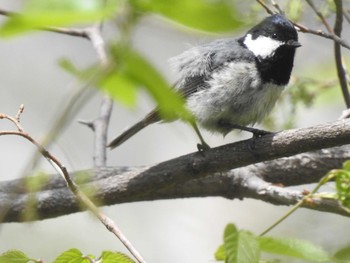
[132,0,245,32]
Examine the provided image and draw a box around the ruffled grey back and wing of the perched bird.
[170,38,255,98]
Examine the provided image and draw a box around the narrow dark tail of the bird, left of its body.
[107,111,159,150]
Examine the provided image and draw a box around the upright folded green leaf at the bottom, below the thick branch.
[220,224,260,263]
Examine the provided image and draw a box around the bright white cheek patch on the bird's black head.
[244,34,283,58]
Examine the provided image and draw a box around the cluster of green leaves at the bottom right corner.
[215,224,350,263]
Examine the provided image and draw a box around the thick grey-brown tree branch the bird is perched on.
[0,120,350,222]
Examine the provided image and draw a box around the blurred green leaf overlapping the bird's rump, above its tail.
[106,45,193,121]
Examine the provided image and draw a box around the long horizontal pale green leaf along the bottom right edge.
[258,236,330,262]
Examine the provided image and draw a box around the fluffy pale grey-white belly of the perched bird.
[187,62,284,134]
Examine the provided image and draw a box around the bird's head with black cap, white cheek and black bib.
[240,14,301,85]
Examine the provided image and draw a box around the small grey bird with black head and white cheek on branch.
[108,14,301,150]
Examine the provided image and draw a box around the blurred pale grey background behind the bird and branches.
[0,0,350,263]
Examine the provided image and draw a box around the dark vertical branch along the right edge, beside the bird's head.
[333,0,350,109]
